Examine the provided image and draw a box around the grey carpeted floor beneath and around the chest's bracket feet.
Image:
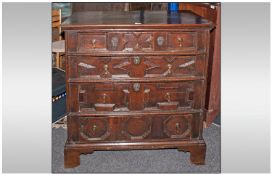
[52,125,221,173]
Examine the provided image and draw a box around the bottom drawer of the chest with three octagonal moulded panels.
[68,113,202,142]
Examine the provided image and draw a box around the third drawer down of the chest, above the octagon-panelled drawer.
[68,80,204,112]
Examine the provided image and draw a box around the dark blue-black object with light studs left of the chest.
[52,68,66,123]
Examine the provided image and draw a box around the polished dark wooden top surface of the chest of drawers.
[62,11,213,30]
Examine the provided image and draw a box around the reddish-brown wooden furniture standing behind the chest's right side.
[179,3,221,127]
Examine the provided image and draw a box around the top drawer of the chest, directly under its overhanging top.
[66,31,206,54]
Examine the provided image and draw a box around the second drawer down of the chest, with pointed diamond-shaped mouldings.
[68,55,205,79]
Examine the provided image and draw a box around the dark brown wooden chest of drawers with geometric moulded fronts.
[62,11,212,167]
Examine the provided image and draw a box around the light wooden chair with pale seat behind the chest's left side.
[52,9,65,69]
